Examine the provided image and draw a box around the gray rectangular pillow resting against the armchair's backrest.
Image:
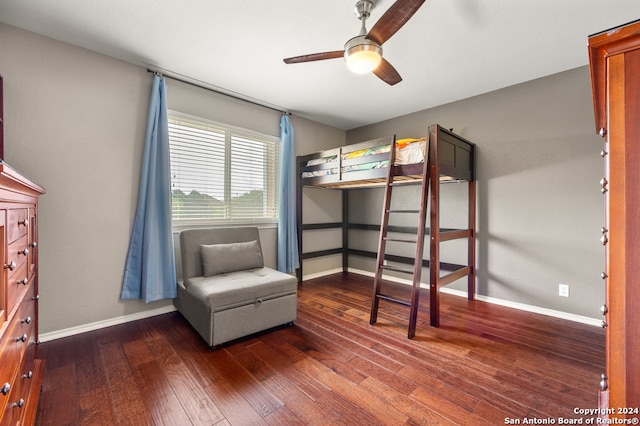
[200,240,264,277]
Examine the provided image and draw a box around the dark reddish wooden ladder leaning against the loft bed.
[369,138,430,339]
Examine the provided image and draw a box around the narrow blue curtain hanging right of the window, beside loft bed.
[278,115,300,273]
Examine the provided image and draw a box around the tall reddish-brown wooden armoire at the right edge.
[589,21,640,412]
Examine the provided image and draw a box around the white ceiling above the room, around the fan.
[0,0,640,130]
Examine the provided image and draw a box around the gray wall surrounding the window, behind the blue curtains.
[0,24,345,333]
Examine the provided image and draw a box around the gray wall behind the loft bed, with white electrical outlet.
[347,67,604,318]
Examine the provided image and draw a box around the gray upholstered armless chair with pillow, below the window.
[174,227,298,346]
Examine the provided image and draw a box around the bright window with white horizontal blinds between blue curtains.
[169,112,280,225]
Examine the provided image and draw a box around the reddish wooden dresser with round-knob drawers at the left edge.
[0,163,44,426]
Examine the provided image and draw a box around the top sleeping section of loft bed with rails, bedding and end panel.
[298,127,473,188]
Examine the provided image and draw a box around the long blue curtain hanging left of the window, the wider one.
[120,75,176,303]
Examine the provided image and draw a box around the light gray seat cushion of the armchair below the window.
[184,268,298,311]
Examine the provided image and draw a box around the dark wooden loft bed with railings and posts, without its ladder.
[296,124,476,327]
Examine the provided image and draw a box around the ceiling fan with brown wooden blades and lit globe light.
[284,0,425,86]
